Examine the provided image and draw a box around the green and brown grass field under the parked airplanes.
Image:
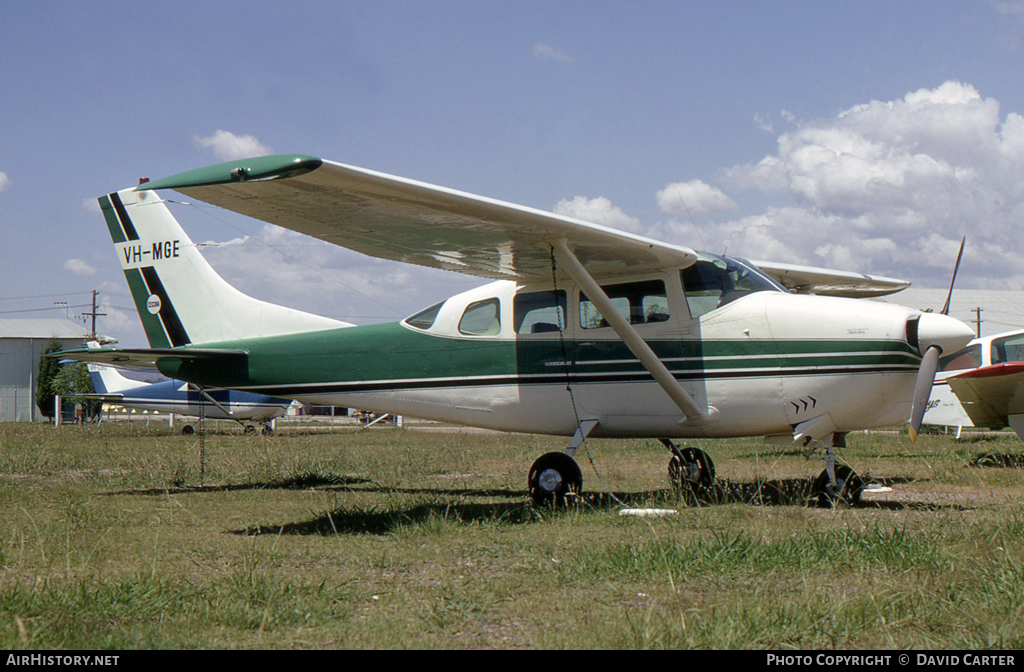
[0,423,1024,649]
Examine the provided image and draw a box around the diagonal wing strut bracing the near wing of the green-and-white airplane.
[552,238,718,425]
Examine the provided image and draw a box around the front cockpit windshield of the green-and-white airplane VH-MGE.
[679,252,786,318]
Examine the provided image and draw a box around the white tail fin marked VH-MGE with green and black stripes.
[99,190,351,347]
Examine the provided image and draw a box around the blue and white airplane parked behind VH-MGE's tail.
[75,364,292,434]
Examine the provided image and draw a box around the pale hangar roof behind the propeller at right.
[882,287,1024,336]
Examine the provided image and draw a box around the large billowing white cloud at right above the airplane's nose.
[696,82,1024,288]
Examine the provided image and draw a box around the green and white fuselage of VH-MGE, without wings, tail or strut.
[153,264,937,444]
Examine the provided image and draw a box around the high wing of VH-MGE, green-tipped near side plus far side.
[138,155,909,297]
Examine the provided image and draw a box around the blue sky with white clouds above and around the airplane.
[0,0,1024,347]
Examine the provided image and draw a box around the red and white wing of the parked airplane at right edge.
[946,362,1024,433]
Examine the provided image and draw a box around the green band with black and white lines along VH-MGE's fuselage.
[164,323,921,395]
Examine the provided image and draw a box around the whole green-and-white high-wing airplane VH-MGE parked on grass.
[61,155,972,503]
